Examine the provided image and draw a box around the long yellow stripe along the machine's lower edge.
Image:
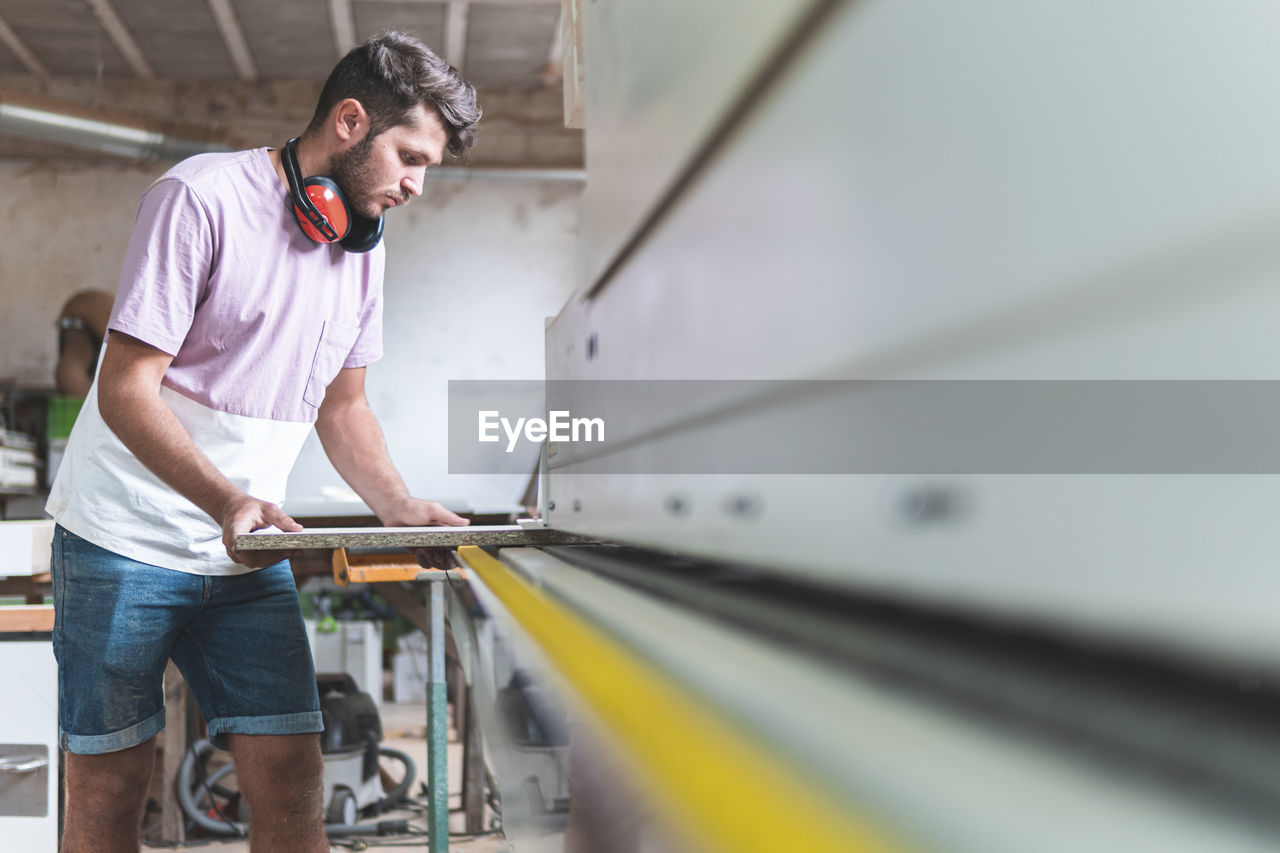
[458,546,908,853]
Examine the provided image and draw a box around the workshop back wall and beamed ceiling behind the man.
[0,0,584,506]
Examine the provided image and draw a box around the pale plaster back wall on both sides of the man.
[0,163,581,508]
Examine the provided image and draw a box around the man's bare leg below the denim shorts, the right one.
[230,734,329,853]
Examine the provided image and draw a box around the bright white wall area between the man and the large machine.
[289,171,581,510]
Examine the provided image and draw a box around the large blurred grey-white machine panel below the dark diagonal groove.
[548,0,1280,670]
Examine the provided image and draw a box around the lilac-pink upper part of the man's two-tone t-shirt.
[109,149,383,421]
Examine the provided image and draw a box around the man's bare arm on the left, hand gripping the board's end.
[97,332,302,569]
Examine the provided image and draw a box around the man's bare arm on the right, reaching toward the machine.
[316,368,467,528]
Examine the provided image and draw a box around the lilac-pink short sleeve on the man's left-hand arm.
[108,178,214,355]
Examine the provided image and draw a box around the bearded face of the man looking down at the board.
[329,104,449,219]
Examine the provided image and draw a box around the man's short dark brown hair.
[307,31,480,158]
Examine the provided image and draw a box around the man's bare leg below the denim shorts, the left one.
[61,738,156,853]
